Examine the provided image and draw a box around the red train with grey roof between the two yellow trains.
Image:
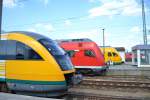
[56,39,107,74]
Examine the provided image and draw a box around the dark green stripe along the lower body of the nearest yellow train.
[6,79,66,85]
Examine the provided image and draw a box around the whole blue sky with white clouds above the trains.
[2,0,150,51]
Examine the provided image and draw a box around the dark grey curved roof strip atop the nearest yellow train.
[3,31,50,40]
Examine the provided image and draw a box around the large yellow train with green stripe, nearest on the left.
[0,31,75,96]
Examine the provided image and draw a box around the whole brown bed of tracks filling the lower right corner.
[66,76,150,100]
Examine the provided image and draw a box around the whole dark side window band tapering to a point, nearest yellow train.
[0,40,42,60]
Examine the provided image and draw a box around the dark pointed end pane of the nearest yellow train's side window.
[16,42,42,60]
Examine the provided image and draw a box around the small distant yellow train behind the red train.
[100,47,122,64]
